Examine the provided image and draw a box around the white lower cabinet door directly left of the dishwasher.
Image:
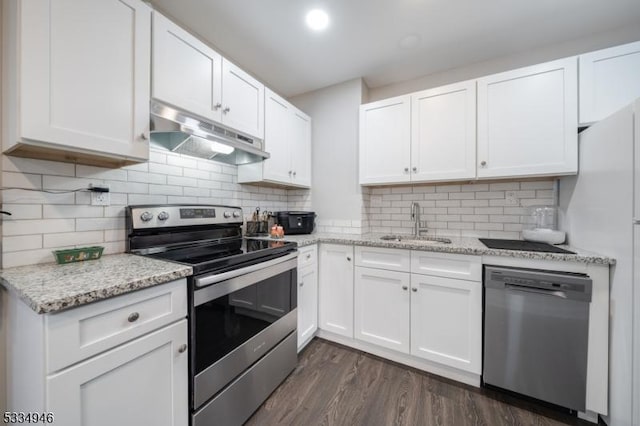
[411,274,482,374]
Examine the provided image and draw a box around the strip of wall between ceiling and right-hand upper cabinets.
[368,25,640,102]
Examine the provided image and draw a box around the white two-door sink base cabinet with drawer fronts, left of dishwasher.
[350,247,482,377]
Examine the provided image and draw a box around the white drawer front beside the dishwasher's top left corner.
[411,250,482,281]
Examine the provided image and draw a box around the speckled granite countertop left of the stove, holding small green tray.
[0,253,193,314]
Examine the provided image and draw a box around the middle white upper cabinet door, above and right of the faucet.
[411,80,476,182]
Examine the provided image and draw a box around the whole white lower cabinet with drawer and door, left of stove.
[7,279,189,426]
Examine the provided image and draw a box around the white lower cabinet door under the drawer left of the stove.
[46,320,189,426]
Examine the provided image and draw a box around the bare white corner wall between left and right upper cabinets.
[289,78,363,233]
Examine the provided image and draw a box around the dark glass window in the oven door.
[194,269,297,374]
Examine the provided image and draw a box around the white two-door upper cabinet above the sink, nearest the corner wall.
[360,81,476,185]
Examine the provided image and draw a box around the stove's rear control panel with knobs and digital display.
[127,205,242,229]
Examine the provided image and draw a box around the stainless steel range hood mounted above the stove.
[151,101,270,165]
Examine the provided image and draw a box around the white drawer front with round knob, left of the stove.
[45,279,187,373]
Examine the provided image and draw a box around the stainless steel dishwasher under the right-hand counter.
[482,266,592,411]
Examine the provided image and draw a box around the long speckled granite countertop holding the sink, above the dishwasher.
[248,233,616,265]
